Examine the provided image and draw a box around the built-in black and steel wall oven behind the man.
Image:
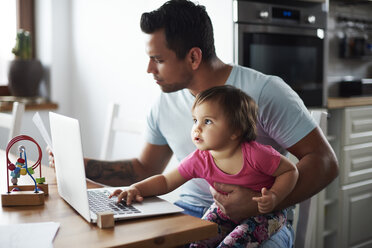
[233,0,328,107]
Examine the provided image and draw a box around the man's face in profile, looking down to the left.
[146,30,192,93]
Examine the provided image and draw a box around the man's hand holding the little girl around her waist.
[210,183,260,221]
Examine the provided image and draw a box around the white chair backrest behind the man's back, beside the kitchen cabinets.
[295,110,327,248]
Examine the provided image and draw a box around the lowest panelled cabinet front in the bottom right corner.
[340,180,372,248]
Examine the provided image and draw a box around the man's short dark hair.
[141,0,216,61]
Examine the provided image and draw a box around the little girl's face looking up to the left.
[191,101,236,150]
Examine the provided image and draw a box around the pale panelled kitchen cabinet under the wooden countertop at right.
[323,105,372,247]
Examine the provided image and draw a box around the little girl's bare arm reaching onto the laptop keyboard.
[110,168,187,205]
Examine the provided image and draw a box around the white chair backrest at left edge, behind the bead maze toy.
[0,102,25,143]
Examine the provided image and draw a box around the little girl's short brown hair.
[192,85,258,142]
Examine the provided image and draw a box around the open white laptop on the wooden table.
[49,112,183,223]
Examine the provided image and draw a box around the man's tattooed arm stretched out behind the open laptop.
[84,143,173,186]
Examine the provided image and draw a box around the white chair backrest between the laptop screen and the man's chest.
[100,103,145,159]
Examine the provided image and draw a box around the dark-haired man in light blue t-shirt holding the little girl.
[64,0,338,247]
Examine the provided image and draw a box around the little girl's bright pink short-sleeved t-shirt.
[178,141,280,191]
